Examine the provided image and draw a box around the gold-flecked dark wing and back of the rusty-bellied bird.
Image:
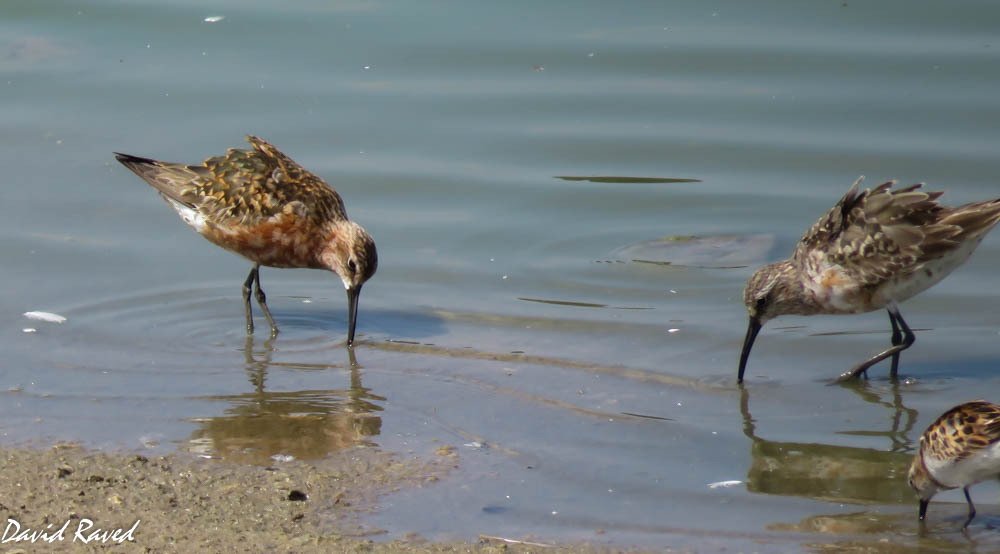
[119,136,347,226]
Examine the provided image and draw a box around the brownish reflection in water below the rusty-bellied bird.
[190,336,385,465]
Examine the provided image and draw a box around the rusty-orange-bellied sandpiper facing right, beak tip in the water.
[115,136,378,345]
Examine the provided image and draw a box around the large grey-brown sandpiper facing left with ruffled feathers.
[737,177,1000,383]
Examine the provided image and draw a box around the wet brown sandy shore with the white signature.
[0,445,616,552]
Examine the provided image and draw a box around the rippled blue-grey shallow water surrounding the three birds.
[0,0,1000,551]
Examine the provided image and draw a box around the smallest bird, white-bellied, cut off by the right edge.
[909,400,1000,531]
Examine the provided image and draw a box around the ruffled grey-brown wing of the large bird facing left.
[793,179,1000,286]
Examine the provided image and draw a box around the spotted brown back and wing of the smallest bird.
[920,400,1000,462]
